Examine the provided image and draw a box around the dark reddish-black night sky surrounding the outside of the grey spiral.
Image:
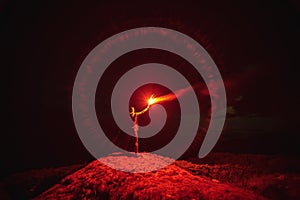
[0,0,300,178]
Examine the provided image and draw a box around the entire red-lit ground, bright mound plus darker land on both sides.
[0,153,300,199]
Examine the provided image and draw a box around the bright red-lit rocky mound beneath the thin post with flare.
[36,154,264,199]
